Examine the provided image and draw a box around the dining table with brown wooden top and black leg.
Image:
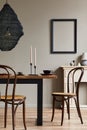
[0,74,57,126]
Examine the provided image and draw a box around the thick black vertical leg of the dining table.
[37,79,43,126]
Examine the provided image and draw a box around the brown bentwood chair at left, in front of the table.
[0,65,26,130]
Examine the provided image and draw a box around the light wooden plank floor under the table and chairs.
[0,108,87,130]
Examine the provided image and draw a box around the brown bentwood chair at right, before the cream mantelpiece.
[51,67,84,125]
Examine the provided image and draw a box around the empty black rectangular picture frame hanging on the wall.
[50,19,77,54]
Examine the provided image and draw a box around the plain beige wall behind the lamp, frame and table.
[0,0,87,106]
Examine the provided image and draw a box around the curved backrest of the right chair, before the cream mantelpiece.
[67,67,84,95]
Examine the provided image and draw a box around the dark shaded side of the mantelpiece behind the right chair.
[52,67,64,108]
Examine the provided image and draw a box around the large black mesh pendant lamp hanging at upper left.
[0,1,24,51]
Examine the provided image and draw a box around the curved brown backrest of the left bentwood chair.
[0,65,17,100]
